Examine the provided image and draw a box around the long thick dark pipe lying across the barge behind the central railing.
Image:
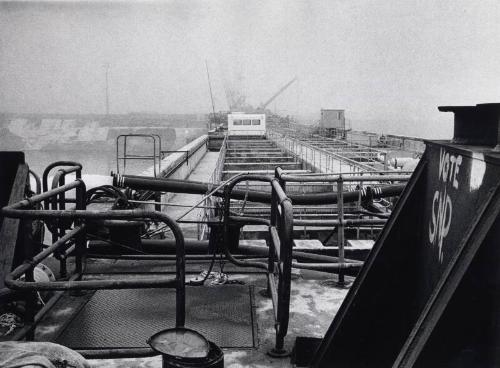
[113,174,406,205]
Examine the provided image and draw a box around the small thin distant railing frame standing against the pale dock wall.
[116,134,161,177]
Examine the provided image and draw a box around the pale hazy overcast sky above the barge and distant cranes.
[0,0,500,137]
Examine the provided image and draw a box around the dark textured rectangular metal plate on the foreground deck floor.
[56,285,257,349]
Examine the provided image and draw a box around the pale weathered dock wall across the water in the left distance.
[0,114,207,151]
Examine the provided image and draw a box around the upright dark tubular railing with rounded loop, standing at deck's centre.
[223,167,293,356]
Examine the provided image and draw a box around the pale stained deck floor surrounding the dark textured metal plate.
[30,258,352,368]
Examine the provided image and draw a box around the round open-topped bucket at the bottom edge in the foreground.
[148,328,224,368]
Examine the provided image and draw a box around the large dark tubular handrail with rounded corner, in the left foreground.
[0,179,186,339]
